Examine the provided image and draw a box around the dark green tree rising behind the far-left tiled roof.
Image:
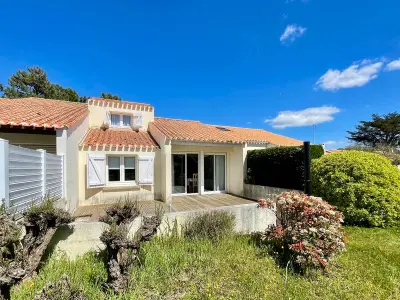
[0,67,85,102]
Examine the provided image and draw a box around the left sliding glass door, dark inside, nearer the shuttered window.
[172,153,199,194]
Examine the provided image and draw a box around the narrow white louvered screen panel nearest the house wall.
[46,153,63,197]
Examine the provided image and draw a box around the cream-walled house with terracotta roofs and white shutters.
[0,98,302,210]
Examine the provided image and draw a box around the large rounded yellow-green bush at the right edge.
[311,150,400,227]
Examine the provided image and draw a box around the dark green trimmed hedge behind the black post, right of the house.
[246,145,324,190]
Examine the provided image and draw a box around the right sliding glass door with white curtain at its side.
[204,154,226,192]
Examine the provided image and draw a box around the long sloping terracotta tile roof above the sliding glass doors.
[150,118,303,146]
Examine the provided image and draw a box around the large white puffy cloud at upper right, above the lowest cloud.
[316,59,383,91]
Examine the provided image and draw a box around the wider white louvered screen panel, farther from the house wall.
[8,145,43,212]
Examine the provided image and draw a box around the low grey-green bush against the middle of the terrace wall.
[182,211,235,241]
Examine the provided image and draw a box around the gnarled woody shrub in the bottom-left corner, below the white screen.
[0,196,73,299]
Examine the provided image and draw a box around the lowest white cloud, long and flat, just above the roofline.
[265,106,340,129]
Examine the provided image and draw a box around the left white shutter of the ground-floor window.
[86,154,106,188]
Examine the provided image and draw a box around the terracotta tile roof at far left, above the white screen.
[0,97,88,128]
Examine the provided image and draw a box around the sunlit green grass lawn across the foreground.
[12,227,400,300]
